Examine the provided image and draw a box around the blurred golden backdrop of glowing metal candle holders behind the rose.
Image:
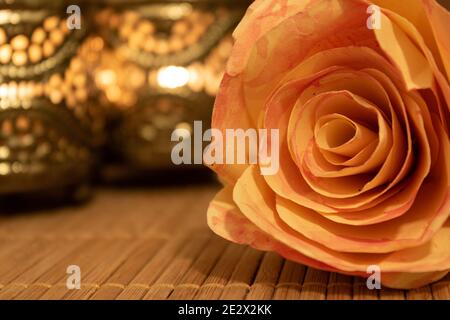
[0,0,249,200]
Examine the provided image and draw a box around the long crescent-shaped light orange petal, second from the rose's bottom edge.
[233,166,450,273]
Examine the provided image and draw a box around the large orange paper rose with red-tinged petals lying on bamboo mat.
[208,0,450,289]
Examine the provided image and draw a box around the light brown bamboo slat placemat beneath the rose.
[0,185,450,300]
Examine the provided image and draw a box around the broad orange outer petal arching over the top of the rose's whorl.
[237,0,379,129]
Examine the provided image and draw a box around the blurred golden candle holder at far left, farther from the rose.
[0,0,104,194]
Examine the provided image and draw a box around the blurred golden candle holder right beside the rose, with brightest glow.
[92,0,249,170]
